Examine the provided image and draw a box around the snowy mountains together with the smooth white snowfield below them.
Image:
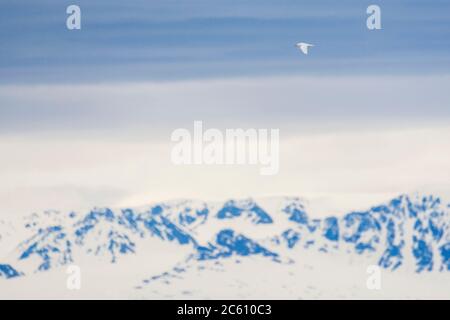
[0,195,450,299]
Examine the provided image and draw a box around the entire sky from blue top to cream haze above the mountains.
[0,0,450,217]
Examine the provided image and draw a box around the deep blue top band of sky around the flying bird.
[0,0,450,83]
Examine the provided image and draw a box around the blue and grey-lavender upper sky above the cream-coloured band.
[0,0,450,132]
